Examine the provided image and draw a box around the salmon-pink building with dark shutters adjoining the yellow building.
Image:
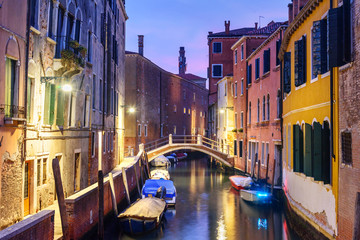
[245,23,284,186]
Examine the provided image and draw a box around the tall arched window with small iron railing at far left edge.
[5,57,19,117]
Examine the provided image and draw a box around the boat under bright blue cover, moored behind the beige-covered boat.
[141,179,176,205]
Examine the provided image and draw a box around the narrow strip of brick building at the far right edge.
[338,1,360,239]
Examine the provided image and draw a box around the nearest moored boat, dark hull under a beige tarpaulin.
[118,197,166,234]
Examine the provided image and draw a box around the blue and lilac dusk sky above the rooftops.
[125,0,291,78]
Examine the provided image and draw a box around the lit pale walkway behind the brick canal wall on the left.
[43,157,135,240]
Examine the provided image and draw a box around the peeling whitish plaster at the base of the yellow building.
[284,171,337,234]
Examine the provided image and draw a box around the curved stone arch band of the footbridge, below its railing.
[147,144,234,167]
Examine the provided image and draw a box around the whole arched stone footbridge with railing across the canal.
[139,134,234,167]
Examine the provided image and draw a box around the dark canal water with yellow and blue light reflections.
[105,157,299,240]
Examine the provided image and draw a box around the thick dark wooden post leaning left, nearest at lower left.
[52,158,69,240]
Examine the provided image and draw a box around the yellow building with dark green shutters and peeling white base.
[279,0,352,238]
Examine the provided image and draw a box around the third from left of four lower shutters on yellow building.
[313,122,322,181]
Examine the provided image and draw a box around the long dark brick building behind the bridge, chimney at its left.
[125,38,208,156]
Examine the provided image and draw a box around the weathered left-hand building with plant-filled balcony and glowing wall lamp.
[1,0,127,229]
